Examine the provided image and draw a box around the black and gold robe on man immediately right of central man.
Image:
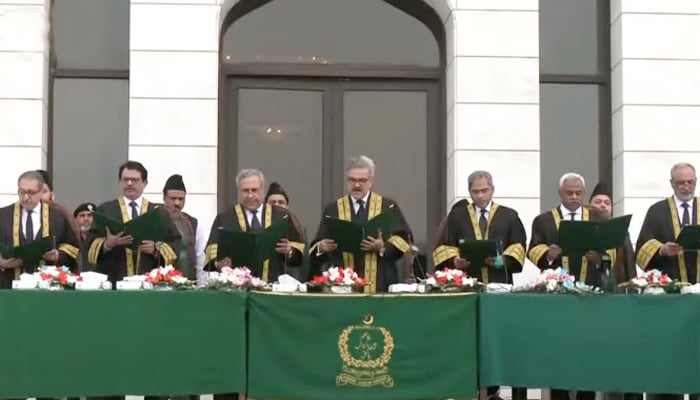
[433,202,527,283]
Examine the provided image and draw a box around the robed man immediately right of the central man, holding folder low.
[433,171,527,400]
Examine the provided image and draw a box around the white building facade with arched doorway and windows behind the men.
[0,0,700,268]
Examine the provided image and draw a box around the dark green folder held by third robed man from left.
[216,216,289,268]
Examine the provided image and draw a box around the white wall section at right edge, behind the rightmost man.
[611,0,700,244]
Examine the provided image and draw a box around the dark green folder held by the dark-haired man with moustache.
[92,208,170,248]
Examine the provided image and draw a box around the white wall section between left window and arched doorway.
[129,0,219,234]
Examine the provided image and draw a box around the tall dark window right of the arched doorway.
[540,0,612,210]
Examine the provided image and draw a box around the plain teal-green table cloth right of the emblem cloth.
[479,294,700,393]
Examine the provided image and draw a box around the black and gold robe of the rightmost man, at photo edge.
[637,196,700,283]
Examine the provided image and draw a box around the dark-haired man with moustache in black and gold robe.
[88,161,181,289]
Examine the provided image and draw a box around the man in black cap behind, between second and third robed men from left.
[163,174,207,282]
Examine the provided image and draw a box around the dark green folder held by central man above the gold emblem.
[325,205,395,254]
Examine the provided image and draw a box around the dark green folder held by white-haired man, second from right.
[559,215,632,255]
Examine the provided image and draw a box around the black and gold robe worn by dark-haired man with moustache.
[87,197,182,289]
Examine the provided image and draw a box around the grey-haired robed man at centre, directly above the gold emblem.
[309,156,412,293]
